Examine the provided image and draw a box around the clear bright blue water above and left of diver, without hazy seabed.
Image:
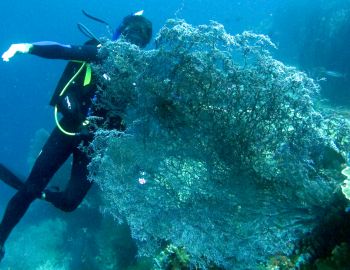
[0,0,350,268]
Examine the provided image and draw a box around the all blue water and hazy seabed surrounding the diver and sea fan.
[0,0,350,270]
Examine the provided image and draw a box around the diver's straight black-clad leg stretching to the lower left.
[0,128,72,252]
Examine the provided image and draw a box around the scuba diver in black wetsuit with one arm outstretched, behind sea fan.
[0,11,152,261]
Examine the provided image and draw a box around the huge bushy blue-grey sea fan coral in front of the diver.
[89,20,350,269]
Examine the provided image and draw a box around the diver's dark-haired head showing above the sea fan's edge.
[112,12,152,48]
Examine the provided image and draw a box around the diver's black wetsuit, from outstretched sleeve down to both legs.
[0,39,105,247]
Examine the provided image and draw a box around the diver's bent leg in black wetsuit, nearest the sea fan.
[45,138,92,212]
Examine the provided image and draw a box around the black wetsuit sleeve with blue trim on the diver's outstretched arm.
[29,41,100,62]
